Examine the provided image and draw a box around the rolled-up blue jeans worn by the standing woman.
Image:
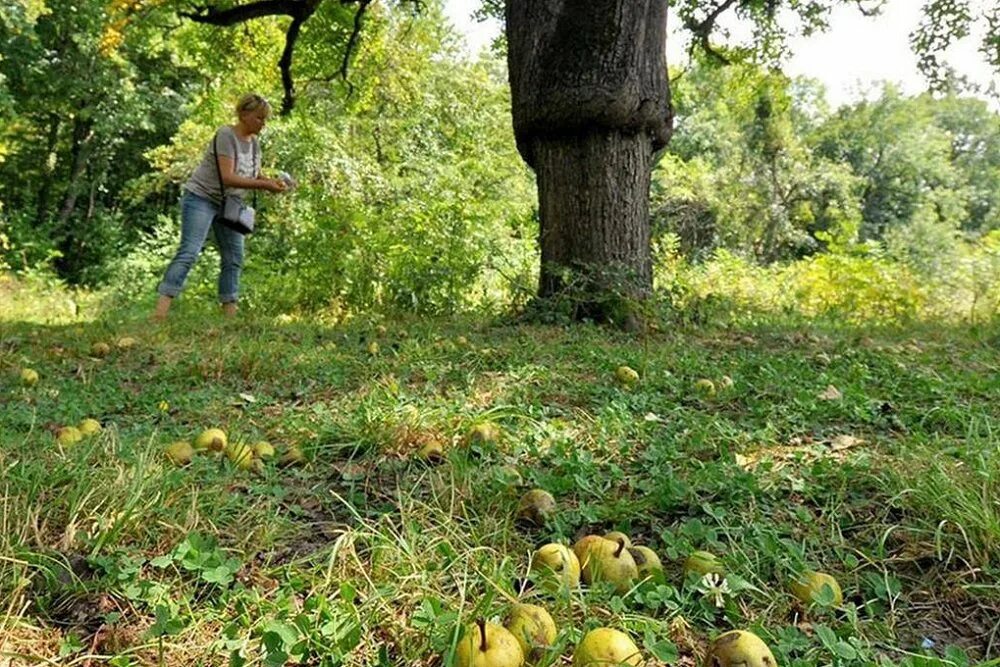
[156,191,243,303]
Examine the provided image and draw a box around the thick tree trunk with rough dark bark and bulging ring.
[505,0,671,321]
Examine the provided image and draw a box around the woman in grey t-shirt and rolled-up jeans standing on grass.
[153,93,286,320]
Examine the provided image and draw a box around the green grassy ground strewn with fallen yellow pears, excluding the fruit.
[0,290,1000,666]
